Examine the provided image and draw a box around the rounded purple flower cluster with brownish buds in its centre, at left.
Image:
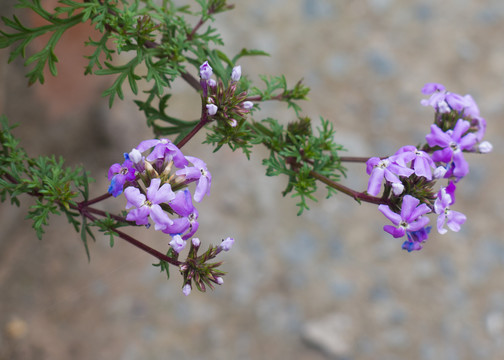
[108,139,234,272]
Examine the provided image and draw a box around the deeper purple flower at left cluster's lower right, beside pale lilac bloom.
[163,189,199,240]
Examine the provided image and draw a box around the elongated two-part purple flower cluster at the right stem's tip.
[366,83,492,252]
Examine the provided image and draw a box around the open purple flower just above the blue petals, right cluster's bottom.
[378,195,431,238]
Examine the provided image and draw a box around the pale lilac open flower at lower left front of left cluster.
[124,178,175,230]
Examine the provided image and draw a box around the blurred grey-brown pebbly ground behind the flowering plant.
[0,0,504,360]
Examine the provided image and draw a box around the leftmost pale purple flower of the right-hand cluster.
[366,157,414,196]
